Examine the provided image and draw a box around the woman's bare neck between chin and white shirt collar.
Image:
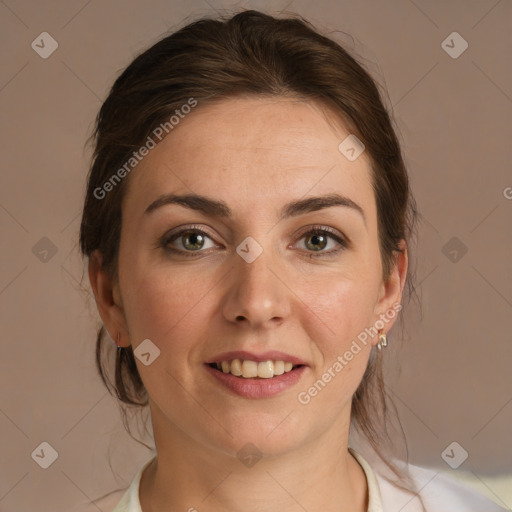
[139,406,368,512]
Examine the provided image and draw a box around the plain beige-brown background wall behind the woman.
[0,0,512,512]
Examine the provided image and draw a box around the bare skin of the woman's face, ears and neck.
[89,97,407,512]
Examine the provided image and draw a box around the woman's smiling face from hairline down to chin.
[97,97,405,455]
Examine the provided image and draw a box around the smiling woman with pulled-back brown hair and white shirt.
[80,11,508,512]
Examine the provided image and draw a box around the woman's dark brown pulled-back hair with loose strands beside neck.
[80,10,421,508]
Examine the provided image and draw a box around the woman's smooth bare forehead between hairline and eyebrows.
[123,97,373,222]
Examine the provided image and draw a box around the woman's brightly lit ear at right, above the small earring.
[374,240,409,340]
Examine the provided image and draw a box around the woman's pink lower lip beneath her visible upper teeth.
[205,365,306,398]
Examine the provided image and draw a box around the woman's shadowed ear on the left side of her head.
[88,251,130,347]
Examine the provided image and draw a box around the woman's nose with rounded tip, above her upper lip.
[223,242,292,329]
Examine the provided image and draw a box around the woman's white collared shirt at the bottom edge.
[107,448,507,512]
